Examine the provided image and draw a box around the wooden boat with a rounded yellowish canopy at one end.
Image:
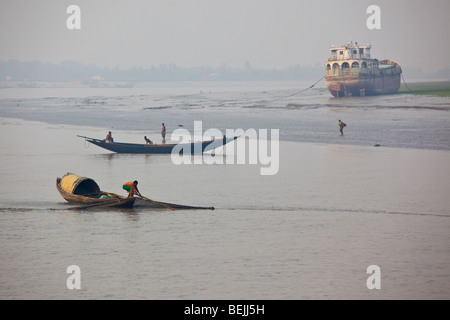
[56,173,135,208]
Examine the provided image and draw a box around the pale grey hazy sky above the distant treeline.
[0,0,450,72]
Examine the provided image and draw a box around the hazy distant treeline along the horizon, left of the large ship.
[0,60,324,82]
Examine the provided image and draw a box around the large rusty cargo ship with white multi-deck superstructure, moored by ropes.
[325,42,402,97]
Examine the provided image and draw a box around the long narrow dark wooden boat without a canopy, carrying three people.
[77,136,238,154]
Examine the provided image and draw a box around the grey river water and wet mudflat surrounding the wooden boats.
[0,83,450,300]
